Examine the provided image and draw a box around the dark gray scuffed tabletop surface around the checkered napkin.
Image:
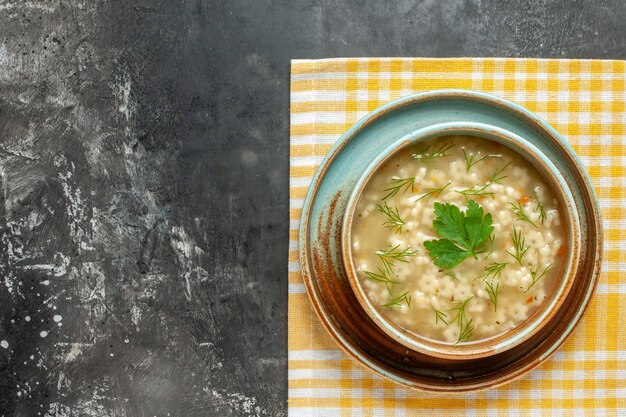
[0,0,626,416]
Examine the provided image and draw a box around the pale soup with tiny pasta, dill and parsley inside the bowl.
[351,135,568,343]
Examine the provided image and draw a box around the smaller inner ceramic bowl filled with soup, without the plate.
[342,122,581,360]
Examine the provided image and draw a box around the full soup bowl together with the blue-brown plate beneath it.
[294,90,603,393]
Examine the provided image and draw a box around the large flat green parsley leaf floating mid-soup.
[424,200,493,269]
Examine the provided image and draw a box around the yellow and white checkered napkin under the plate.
[289,58,626,417]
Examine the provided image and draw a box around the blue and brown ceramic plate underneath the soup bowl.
[299,90,602,392]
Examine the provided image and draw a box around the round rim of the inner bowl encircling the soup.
[341,122,581,360]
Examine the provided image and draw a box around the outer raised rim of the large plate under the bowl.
[298,89,604,393]
